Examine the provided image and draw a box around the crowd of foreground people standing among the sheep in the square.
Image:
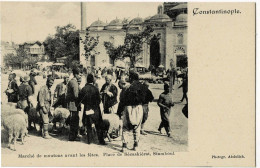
[3,68,188,151]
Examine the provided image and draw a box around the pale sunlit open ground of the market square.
[1,74,188,155]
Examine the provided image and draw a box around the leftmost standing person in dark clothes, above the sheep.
[5,73,18,103]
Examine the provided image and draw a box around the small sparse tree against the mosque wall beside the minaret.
[80,29,100,65]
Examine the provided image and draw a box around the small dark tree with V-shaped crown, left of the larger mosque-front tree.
[104,41,124,65]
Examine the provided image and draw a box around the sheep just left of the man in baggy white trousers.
[101,114,123,142]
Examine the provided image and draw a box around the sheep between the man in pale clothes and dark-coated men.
[51,108,70,133]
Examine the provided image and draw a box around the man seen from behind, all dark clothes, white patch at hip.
[79,74,105,145]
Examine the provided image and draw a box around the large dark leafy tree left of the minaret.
[44,24,79,64]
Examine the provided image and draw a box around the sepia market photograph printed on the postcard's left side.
[1,2,189,161]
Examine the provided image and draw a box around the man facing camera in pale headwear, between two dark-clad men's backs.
[100,75,117,114]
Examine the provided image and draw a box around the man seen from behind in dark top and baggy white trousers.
[121,71,147,152]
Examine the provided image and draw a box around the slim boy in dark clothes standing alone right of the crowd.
[157,83,174,137]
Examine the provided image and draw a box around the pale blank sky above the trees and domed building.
[0,2,162,43]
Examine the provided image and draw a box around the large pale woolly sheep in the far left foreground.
[3,114,28,151]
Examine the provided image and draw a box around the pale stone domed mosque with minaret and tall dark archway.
[80,3,187,69]
